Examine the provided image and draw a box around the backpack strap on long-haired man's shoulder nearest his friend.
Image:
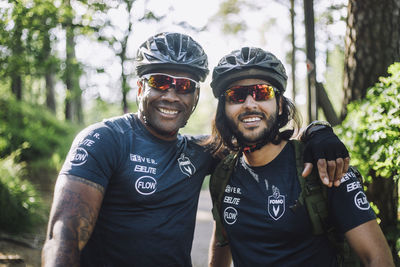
[210,153,238,247]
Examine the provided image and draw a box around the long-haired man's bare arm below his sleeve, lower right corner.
[345,220,394,267]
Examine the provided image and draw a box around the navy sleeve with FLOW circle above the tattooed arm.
[60,123,121,188]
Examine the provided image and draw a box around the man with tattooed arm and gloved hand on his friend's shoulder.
[42,33,348,267]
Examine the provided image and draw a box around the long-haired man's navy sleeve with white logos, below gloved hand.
[328,169,376,233]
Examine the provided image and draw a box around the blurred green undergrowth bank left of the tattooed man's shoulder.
[0,97,78,180]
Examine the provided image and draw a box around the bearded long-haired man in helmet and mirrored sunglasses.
[210,47,393,267]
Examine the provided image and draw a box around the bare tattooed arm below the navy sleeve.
[42,175,104,266]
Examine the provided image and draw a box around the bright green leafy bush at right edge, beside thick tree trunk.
[337,63,400,263]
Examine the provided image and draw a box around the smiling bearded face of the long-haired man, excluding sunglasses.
[225,79,278,145]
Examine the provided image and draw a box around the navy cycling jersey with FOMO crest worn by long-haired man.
[221,143,375,267]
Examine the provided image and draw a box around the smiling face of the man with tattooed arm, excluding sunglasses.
[138,70,199,140]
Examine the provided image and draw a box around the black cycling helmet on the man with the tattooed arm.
[135,32,209,82]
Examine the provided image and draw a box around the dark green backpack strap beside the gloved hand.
[290,140,333,235]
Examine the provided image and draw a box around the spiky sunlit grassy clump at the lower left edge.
[0,151,45,233]
